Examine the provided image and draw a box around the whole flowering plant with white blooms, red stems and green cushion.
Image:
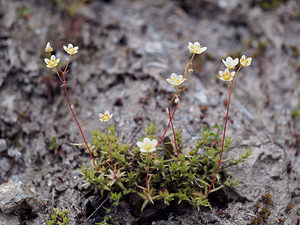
[45,42,252,222]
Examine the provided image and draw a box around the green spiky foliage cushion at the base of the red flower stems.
[81,125,250,217]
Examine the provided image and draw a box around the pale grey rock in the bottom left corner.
[0,181,43,214]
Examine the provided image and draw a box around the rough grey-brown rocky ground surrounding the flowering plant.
[0,0,300,225]
